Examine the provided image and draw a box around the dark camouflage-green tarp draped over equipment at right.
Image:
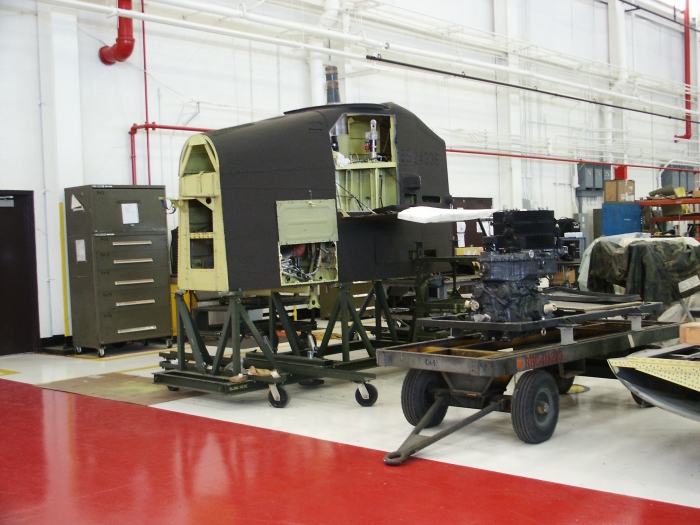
[588,241,700,305]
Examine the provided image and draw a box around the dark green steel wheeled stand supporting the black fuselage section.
[153,283,398,408]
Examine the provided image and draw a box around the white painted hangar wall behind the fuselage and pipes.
[0,0,700,337]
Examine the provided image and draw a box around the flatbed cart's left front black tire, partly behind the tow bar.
[401,368,447,428]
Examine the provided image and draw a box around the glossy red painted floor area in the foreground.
[0,381,700,525]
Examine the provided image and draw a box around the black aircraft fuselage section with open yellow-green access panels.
[178,103,452,292]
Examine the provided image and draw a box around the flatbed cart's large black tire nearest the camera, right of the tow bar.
[510,370,559,445]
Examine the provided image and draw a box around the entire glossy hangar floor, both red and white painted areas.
[0,344,700,524]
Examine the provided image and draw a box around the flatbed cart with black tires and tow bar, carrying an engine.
[377,301,679,465]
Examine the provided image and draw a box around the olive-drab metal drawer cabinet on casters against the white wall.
[65,186,172,348]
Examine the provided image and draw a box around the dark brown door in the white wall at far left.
[0,191,39,355]
